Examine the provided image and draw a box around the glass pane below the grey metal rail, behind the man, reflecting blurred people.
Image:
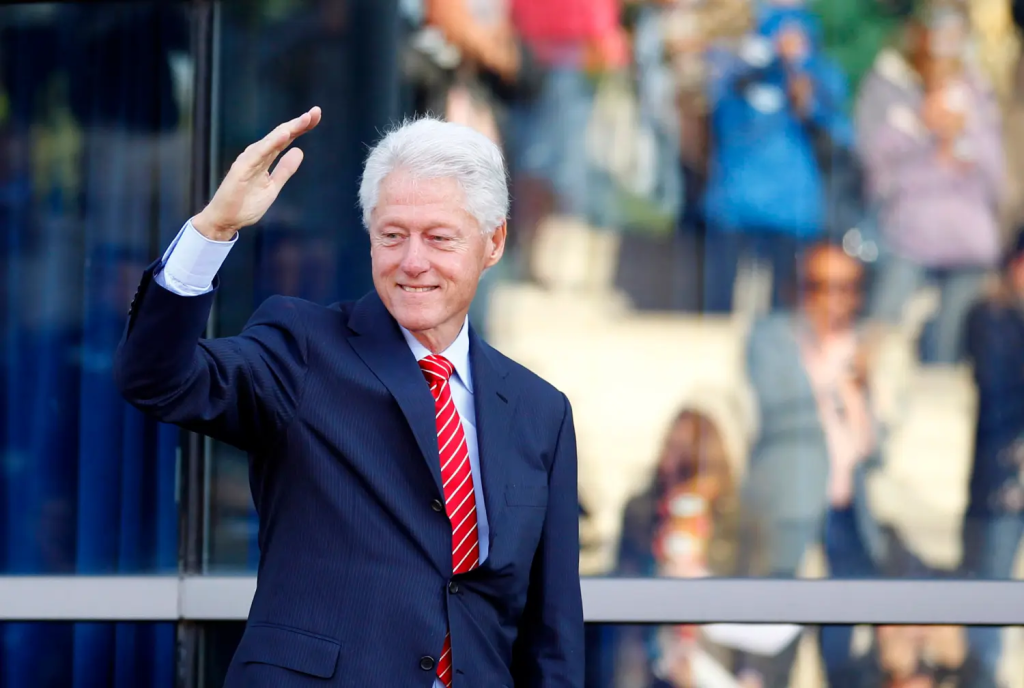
[203,622,1024,688]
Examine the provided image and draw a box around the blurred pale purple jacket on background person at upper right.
[856,50,1006,267]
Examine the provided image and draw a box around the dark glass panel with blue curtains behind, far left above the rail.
[0,2,193,573]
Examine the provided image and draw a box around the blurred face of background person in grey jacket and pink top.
[802,247,863,329]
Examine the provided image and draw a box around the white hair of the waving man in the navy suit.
[359,117,509,234]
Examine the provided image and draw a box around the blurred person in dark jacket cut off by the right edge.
[963,232,1024,674]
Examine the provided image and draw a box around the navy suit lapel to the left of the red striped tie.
[348,293,444,499]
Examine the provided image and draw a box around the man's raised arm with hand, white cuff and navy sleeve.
[114,108,321,449]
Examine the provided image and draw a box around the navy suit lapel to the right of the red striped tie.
[469,327,513,565]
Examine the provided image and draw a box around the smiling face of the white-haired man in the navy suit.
[370,170,505,352]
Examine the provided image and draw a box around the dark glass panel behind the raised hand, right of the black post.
[207,0,398,570]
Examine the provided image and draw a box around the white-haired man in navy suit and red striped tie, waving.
[115,108,584,688]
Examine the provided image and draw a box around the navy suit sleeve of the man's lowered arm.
[512,395,584,688]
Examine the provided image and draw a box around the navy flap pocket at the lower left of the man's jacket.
[234,624,341,679]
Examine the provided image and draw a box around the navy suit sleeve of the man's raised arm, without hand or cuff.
[114,267,306,452]
